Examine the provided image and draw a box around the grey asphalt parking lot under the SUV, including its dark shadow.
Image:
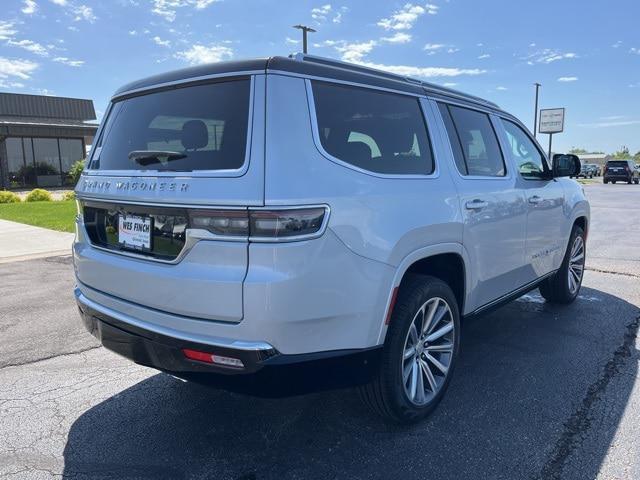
[0,184,640,480]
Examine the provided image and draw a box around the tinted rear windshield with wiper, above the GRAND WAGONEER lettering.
[89,79,250,171]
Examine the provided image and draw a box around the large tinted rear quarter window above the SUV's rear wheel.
[312,82,434,174]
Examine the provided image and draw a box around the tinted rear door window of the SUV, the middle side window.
[441,105,506,177]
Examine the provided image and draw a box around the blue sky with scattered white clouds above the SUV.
[0,0,640,152]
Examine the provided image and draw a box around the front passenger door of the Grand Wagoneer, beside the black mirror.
[499,118,567,281]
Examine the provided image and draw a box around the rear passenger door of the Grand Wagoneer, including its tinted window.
[436,102,527,313]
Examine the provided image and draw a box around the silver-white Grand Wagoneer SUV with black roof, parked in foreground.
[73,55,589,421]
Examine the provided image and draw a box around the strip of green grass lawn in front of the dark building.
[0,200,76,233]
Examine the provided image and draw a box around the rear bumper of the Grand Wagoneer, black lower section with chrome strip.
[75,288,381,397]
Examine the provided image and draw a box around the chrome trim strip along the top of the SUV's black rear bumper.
[73,286,276,351]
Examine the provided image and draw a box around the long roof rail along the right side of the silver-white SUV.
[289,52,500,109]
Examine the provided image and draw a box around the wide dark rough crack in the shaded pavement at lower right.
[536,315,640,479]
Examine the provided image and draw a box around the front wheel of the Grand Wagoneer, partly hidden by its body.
[538,225,587,304]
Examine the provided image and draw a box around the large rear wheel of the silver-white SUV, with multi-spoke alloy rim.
[359,275,460,424]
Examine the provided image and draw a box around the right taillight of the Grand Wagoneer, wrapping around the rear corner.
[189,207,328,242]
